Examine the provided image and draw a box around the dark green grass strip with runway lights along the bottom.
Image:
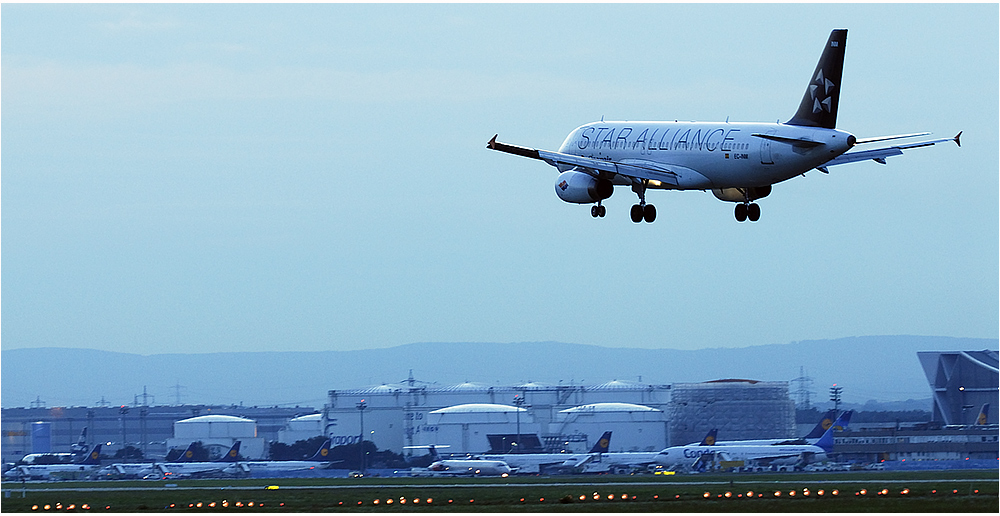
[2,470,1000,513]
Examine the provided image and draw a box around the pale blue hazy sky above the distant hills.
[0,4,1000,354]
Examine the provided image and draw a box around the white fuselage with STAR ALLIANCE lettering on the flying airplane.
[559,122,854,190]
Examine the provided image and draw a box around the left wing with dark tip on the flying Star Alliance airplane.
[486,135,694,186]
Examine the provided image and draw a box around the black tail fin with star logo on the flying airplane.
[787,29,847,129]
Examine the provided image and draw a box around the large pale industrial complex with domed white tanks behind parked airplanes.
[323,378,795,453]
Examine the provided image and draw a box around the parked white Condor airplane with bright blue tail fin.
[656,425,833,469]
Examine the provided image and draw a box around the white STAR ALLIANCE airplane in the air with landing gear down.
[486,29,962,223]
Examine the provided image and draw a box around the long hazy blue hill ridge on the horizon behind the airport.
[0,336,998,410]
